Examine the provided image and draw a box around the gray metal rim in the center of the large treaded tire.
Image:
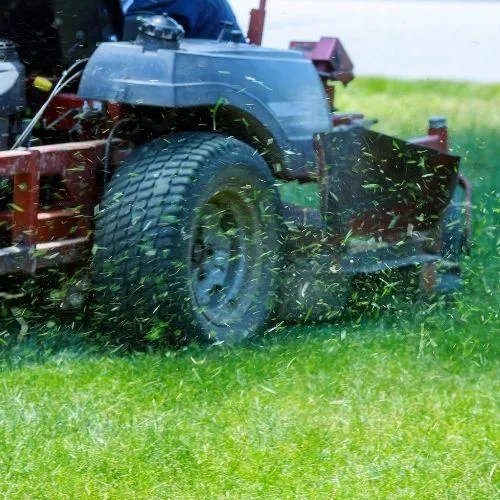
[191,190,262,326]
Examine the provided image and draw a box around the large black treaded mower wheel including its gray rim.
[93,132,280,342]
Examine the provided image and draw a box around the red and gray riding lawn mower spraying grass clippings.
[0,0,471,342]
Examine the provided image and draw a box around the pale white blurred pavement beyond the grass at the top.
[231,0,500,82]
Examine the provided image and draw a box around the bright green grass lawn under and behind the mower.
[0,79,500,499]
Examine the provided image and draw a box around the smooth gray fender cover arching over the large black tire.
[79,40,332,175]
